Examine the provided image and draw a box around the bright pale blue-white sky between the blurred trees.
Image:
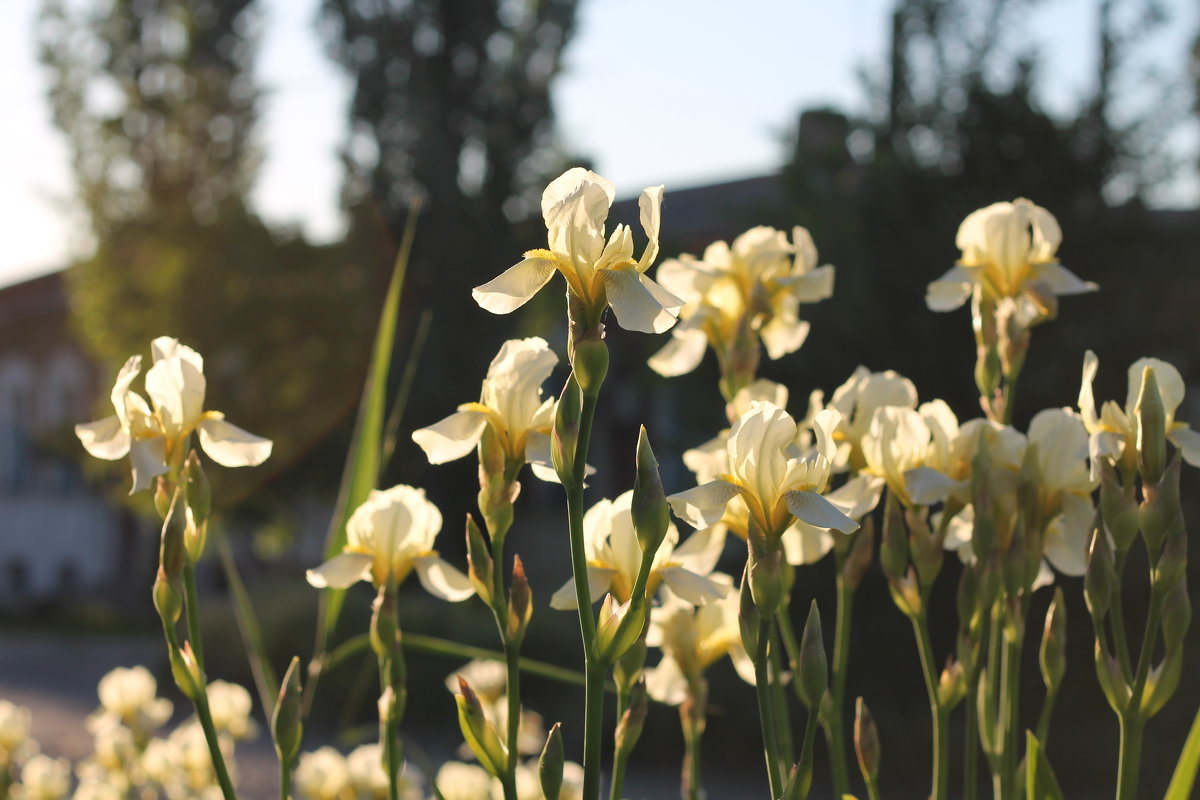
[0,0,1200,285]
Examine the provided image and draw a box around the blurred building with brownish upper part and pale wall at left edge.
[0,273,122,610]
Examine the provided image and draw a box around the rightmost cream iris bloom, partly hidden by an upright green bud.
[1079,350,1200,470]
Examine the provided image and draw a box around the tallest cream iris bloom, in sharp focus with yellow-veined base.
[472,167,683,333]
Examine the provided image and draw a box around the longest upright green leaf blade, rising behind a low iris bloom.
[314,205,419,658]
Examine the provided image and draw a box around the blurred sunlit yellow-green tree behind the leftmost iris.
[38,0,386,510]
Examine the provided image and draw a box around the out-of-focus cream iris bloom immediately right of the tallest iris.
[649,225,834,378]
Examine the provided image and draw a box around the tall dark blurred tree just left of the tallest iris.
[322,0,577,452]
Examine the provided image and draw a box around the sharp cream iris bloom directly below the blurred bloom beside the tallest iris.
[667,402,858,537]
